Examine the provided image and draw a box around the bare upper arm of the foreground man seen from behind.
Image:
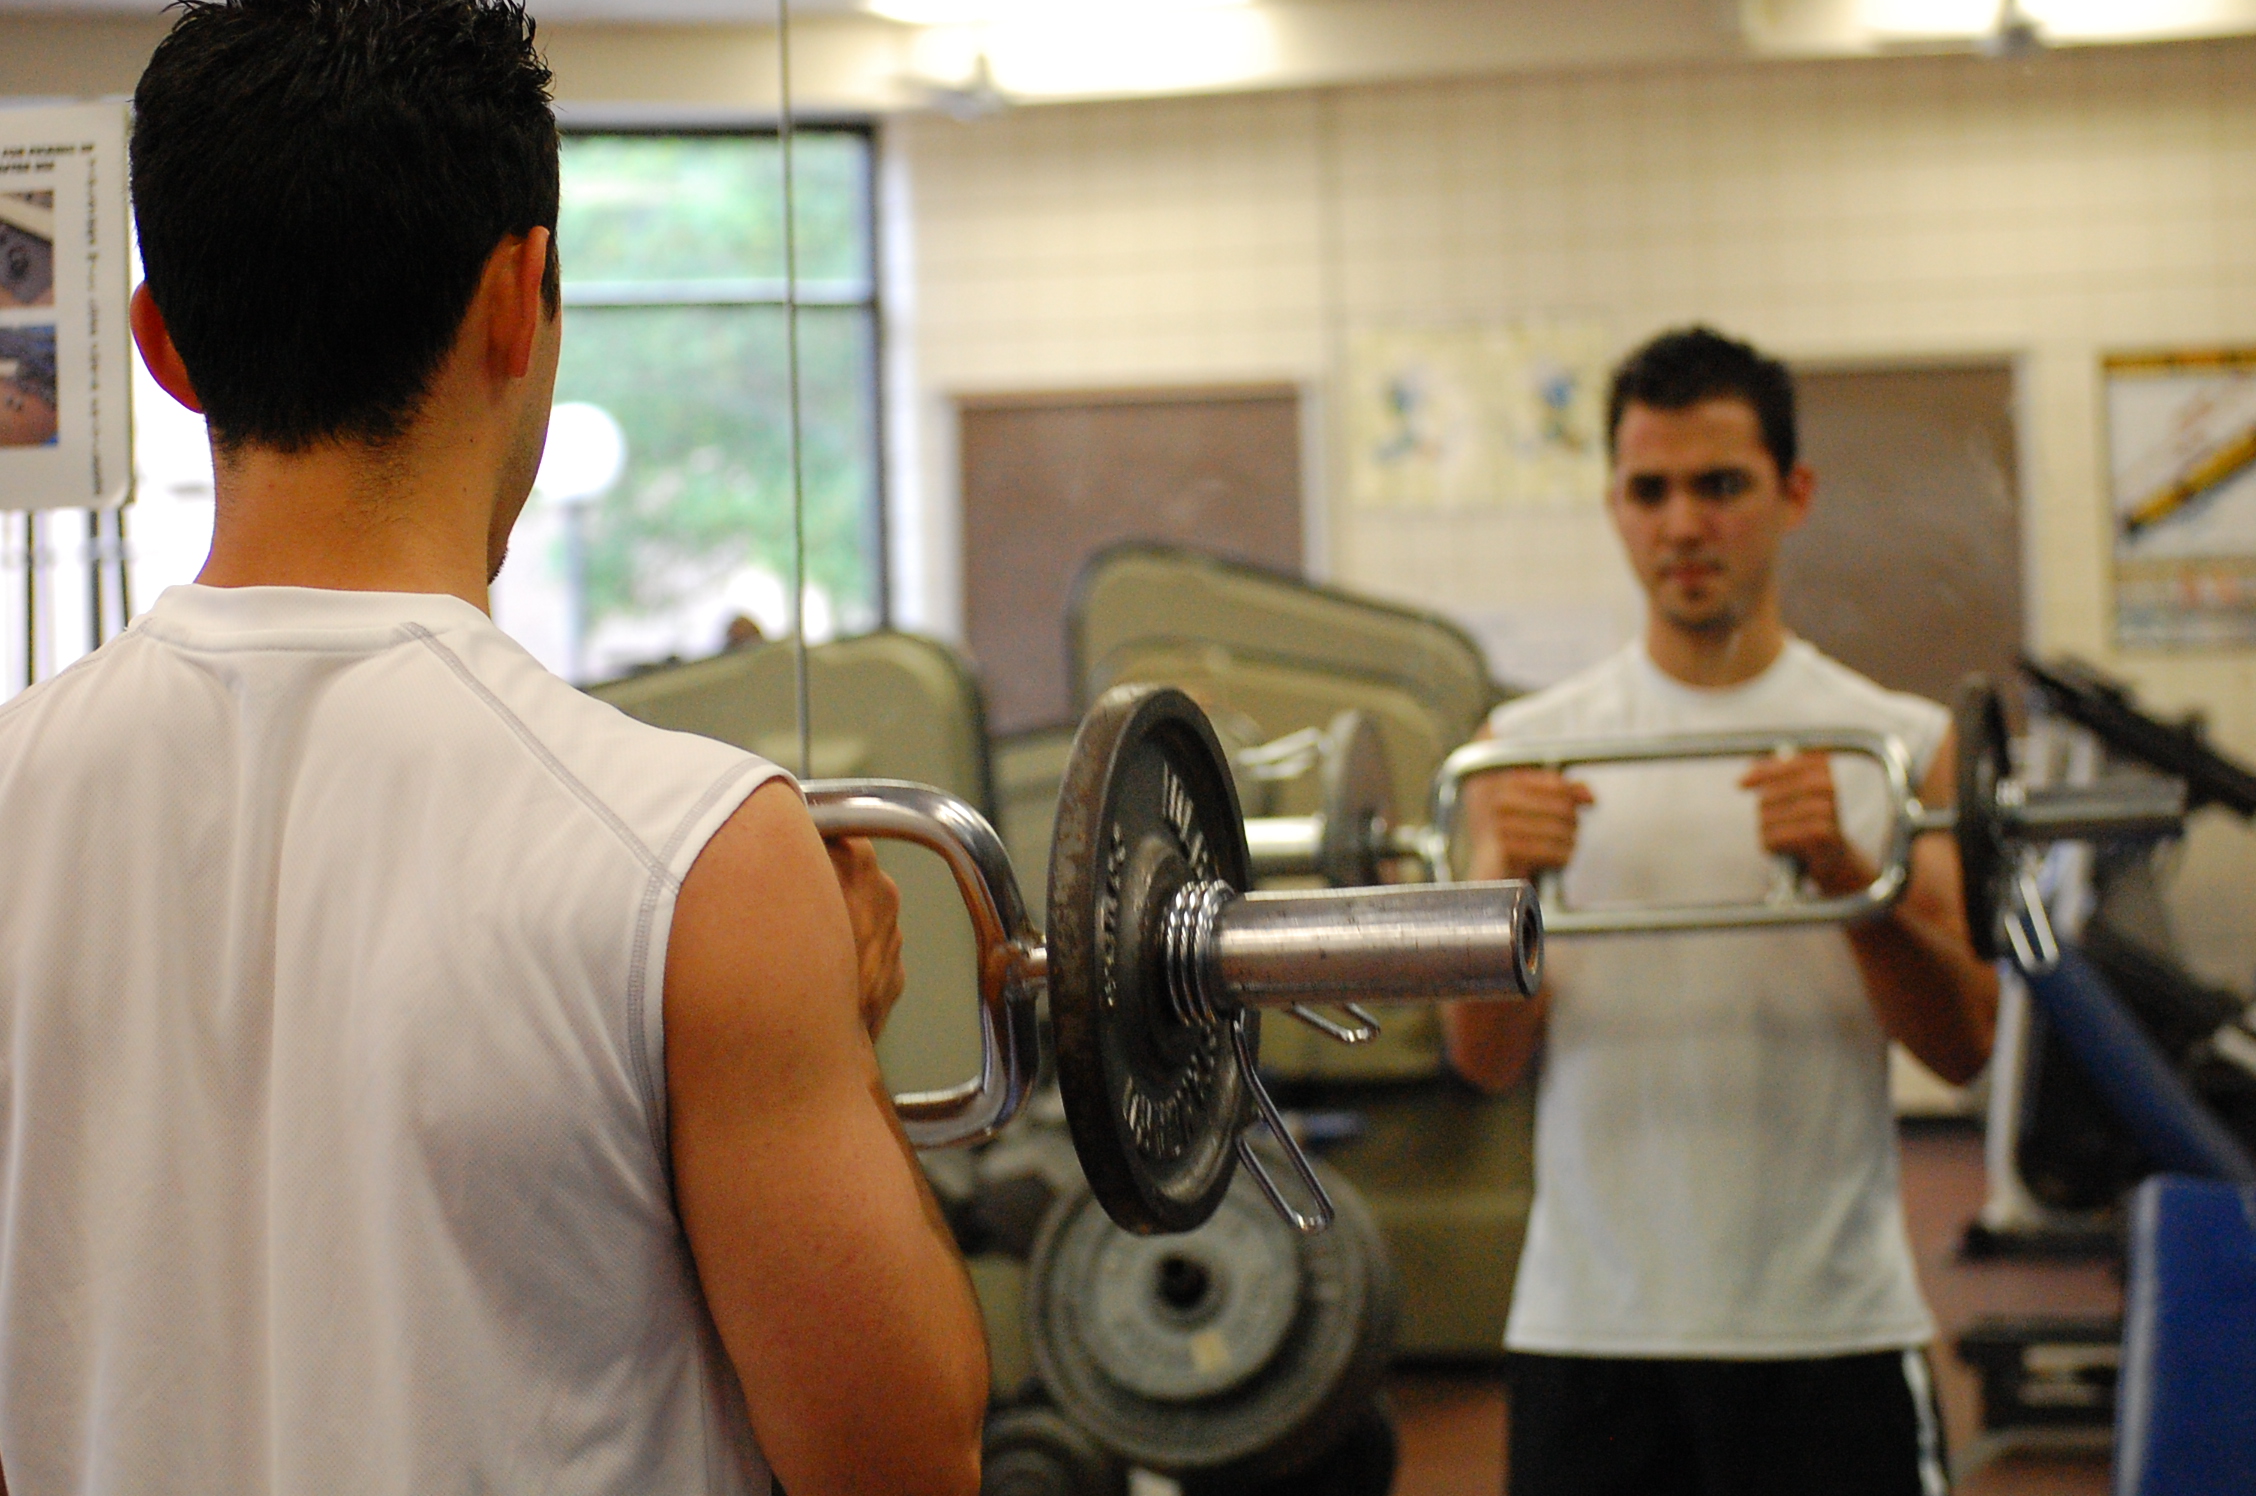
[666,781,988,1496]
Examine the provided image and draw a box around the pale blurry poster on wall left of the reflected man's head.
[1347,320,1611,508]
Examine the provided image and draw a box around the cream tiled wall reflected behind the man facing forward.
[887,41,2256,988]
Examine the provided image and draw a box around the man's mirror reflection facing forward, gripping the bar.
[1446,327,1997,1496]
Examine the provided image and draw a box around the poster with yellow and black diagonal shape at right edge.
[2105,350,2256,648]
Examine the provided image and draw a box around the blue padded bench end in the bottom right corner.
[2114,1176,2256,1496]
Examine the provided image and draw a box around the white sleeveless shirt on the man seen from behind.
[0,587,781,1496]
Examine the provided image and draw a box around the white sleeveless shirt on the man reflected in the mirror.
[1491,639,1949,1358]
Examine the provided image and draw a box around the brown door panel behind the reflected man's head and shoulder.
[1782,363,2021,702]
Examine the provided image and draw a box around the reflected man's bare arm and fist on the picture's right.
[1744,736,1997,1085]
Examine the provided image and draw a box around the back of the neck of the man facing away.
[196,424,494,611]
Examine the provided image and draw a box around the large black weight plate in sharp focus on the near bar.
[1047,686,1252,1234]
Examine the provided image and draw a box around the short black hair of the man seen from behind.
[133,0,557,451]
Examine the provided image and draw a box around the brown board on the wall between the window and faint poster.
[959,386,1302,733]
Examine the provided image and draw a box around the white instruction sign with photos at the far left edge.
[0,104,133,510]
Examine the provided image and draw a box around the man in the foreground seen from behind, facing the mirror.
[0,0,986,1496]
